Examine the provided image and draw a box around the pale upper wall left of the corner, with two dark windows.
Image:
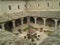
[0,1,25,13]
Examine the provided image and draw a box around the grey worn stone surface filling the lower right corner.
[40,30,60,45]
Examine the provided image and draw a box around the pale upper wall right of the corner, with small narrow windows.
[27,1,60,11]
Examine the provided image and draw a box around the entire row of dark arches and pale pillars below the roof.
[0,12,60,31]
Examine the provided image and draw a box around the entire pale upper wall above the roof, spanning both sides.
[0,0,60,13]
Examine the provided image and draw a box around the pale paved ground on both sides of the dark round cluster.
[18,31,48,45]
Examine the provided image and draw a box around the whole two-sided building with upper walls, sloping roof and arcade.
[0,0,60,31]
